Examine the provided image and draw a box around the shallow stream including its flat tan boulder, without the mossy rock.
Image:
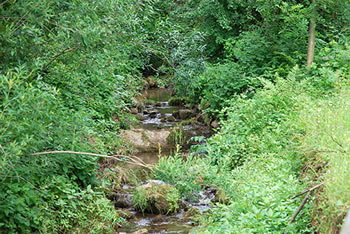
[117,88,215,234]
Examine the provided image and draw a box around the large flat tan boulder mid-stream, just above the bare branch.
[121,129,171,152]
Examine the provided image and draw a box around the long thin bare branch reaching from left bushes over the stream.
[25,151,153,170]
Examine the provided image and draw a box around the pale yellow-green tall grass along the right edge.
[299,87,350,233]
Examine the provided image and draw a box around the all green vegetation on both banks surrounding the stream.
[0,0,350,233]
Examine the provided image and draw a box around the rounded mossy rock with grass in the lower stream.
[132,181,180,214]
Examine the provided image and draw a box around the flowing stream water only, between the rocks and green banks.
[117,88,215,233]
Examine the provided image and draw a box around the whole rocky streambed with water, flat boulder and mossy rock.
[110,88,216,233]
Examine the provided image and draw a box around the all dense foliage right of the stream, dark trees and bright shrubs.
[155,0,350,233]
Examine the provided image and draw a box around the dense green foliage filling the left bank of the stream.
[0,0,167,232]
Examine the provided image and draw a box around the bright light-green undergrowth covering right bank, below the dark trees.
[155,56,349,233]
